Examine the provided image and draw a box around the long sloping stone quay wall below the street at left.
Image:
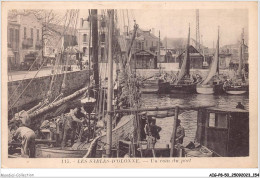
[8,70,89,111]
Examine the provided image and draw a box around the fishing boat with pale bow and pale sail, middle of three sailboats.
[196,26,224,94]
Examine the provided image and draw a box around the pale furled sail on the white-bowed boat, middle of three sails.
[202,29,219,85]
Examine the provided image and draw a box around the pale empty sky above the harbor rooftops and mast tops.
[75,9,248,48]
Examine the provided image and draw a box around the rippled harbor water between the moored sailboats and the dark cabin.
[142,94,249,147]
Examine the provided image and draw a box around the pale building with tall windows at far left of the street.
[7,14,42,69]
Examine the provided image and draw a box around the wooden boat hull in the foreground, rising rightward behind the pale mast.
[36,115,134,158]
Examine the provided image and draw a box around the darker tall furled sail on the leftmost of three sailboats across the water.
[174,24,190,84]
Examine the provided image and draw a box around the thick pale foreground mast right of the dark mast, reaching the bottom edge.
[106,10,114,157]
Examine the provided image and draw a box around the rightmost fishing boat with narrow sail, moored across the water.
[223,30,249,95]
